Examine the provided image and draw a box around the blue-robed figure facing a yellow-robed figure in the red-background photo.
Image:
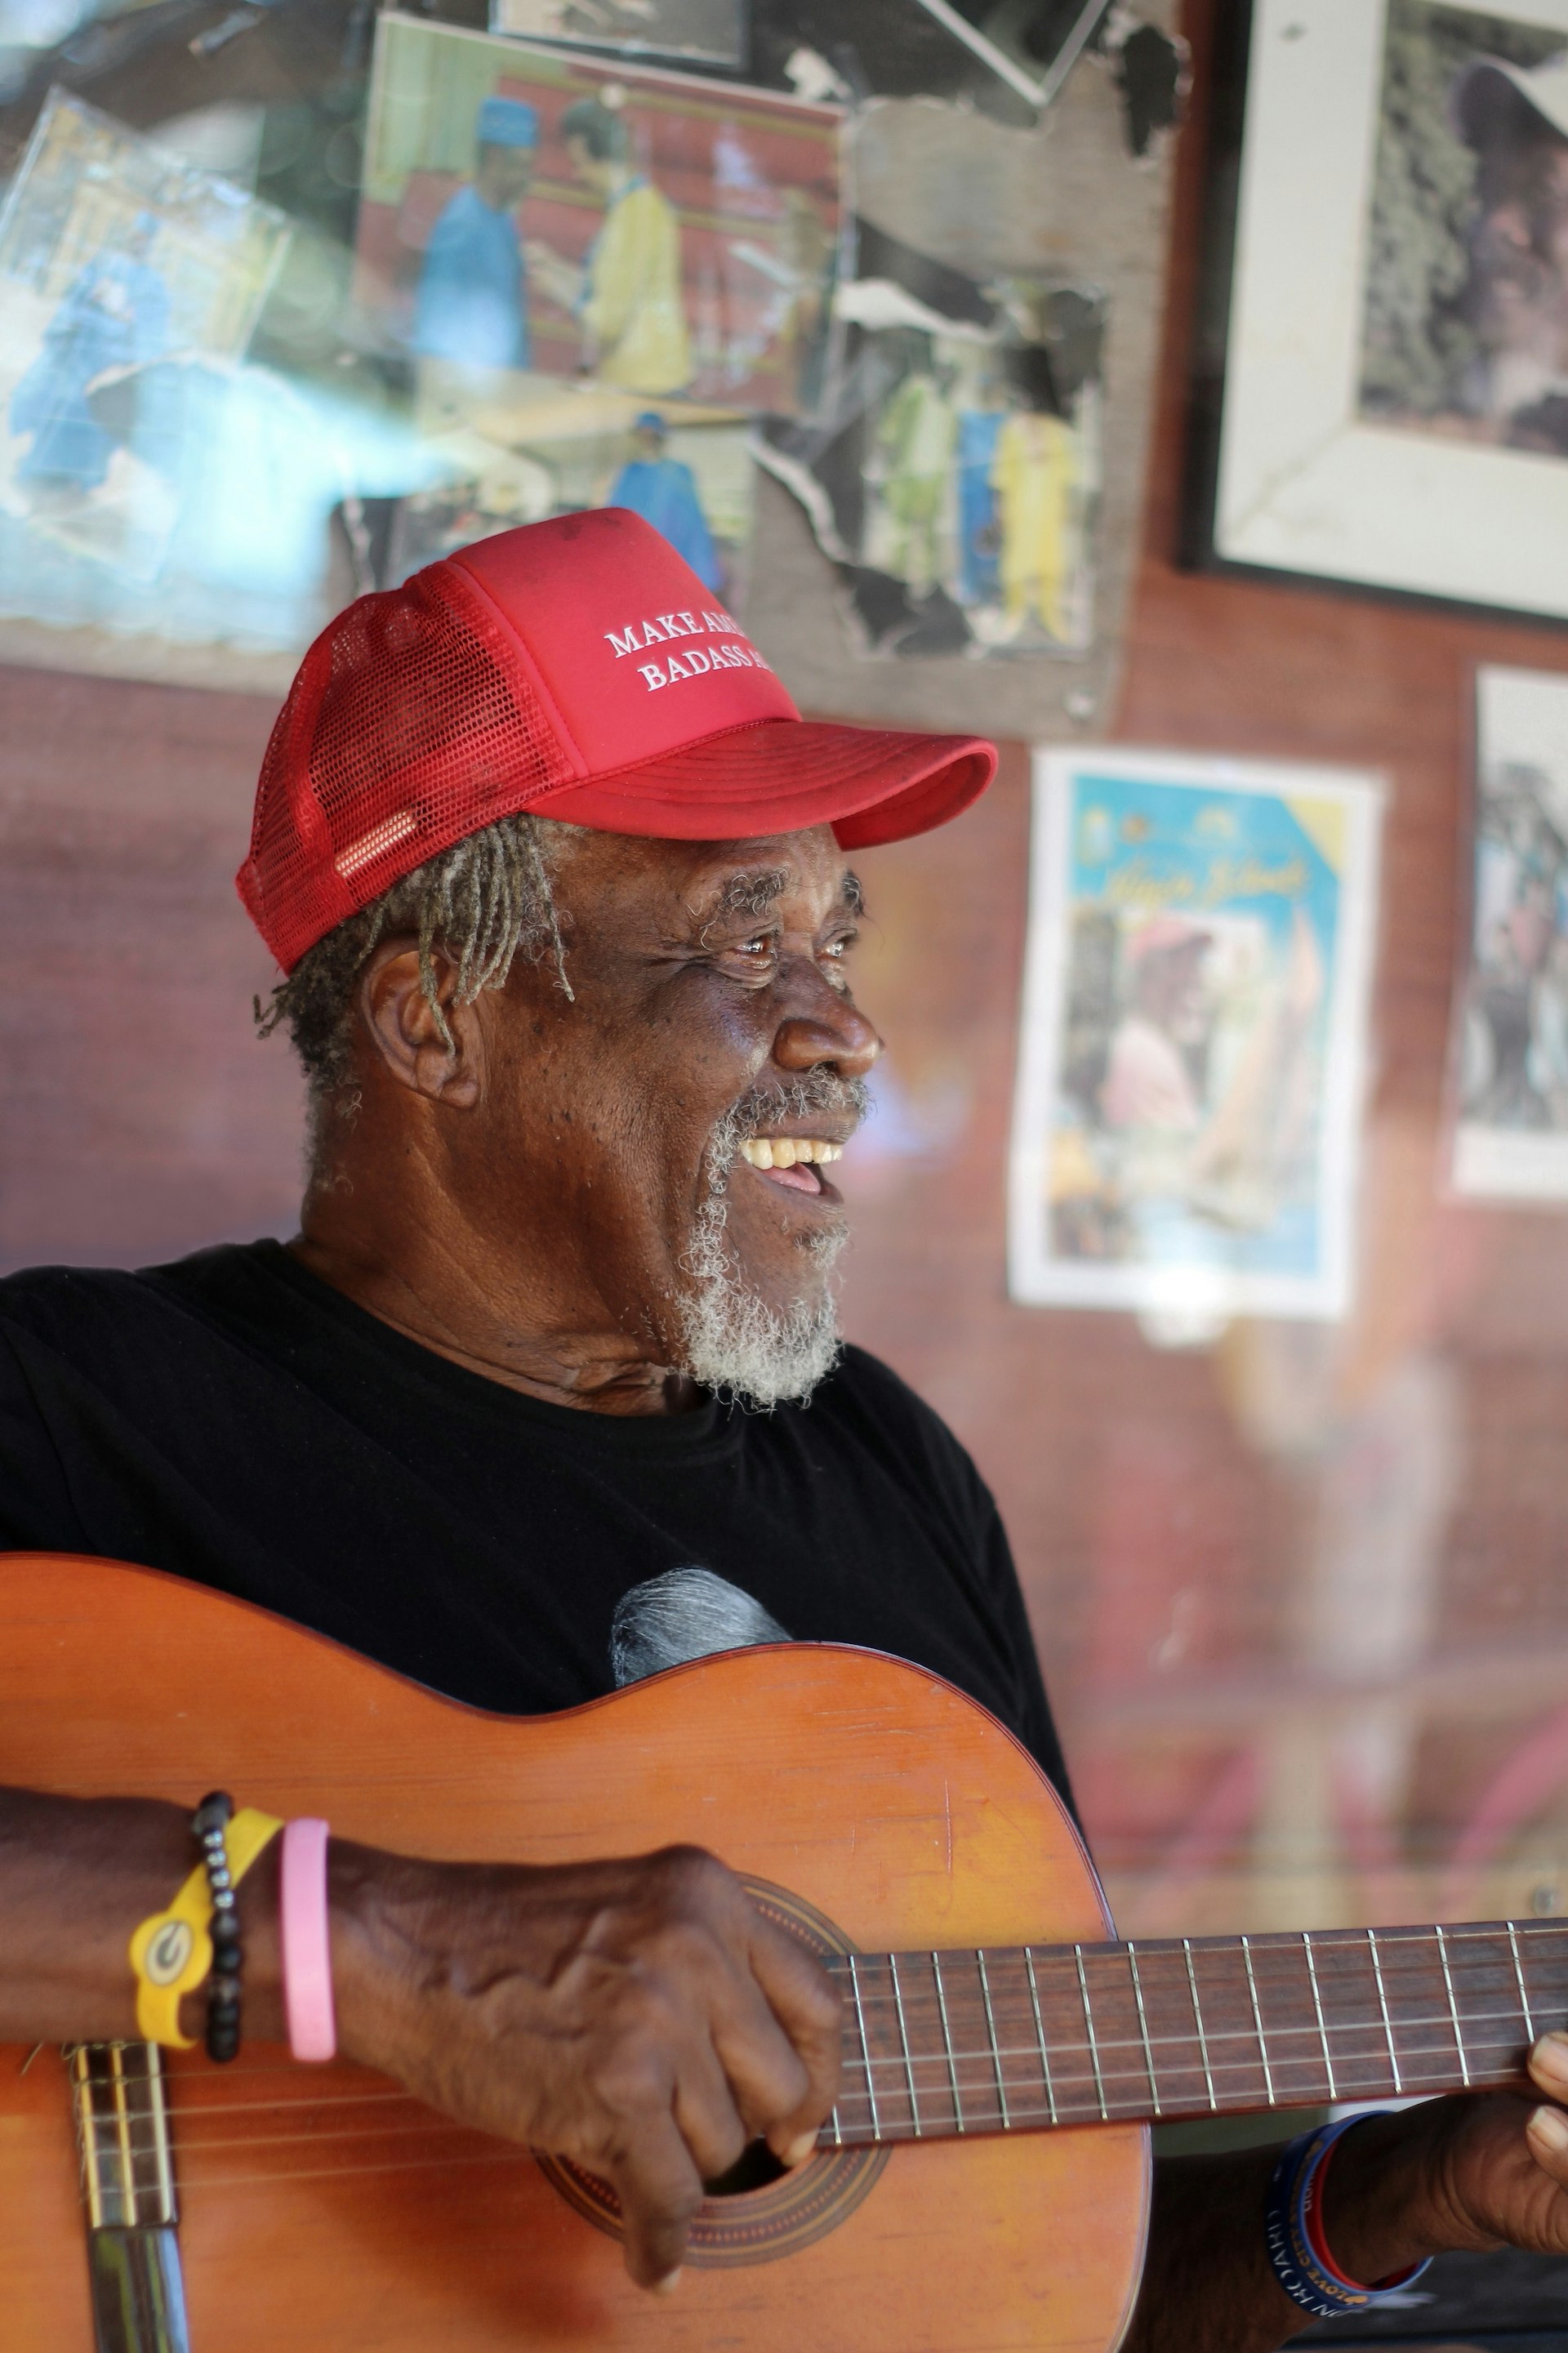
[412,96,539,367]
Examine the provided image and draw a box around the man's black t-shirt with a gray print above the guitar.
[0,1242,1067,1789]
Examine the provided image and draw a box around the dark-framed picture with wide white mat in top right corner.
[1208,0,1568,619]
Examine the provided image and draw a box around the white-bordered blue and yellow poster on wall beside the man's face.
[1008,748,1382,1320]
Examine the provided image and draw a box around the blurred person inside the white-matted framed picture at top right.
[1453,51,1568,449]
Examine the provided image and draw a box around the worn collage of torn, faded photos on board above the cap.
[0,0,1104,684]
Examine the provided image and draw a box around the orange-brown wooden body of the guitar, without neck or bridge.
[0,1555,1149,2353]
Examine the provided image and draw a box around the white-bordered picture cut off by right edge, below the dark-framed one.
[1453,668,1568,1202]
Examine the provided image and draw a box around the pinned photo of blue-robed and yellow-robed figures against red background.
[355,14,843,414]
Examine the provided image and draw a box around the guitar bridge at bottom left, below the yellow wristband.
[66,2043,191,2353]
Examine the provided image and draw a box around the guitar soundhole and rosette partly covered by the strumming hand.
[539,1880,890,2271]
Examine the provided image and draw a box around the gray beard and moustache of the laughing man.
[680,1071,869,1412]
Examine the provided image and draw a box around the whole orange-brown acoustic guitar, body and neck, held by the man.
[0,1553,1568,2353]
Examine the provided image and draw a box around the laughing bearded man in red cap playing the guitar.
[0,510,1568,2324]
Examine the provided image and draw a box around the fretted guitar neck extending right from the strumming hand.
[822,1920,1568,2148]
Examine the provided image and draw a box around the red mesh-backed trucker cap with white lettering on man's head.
[235,506,996,972]
